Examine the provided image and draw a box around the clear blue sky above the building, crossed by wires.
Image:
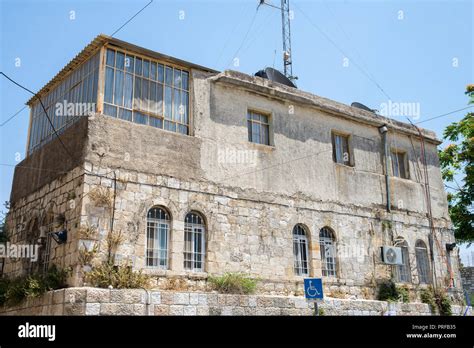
[0,0,474,262]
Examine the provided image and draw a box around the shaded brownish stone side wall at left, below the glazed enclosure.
[3,167,84,282]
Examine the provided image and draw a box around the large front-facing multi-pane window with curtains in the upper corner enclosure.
[104,48,189,134]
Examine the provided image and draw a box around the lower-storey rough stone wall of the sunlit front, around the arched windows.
[78,165,462,299]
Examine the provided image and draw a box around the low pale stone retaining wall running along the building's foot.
[0,287,473,315]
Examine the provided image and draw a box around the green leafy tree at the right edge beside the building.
[439,85,474,243]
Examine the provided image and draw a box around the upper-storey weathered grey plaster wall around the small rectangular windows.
[199,74,448,218]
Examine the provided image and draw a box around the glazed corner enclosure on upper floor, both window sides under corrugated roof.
[28,47,189,154]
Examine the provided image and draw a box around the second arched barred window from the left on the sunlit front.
[184,212,206,272]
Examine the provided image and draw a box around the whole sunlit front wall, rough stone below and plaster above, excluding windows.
[2,66,460,299]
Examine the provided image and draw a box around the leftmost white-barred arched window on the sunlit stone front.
[146,207,171,269]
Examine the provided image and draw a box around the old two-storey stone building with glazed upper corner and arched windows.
[3,35,462,299]
